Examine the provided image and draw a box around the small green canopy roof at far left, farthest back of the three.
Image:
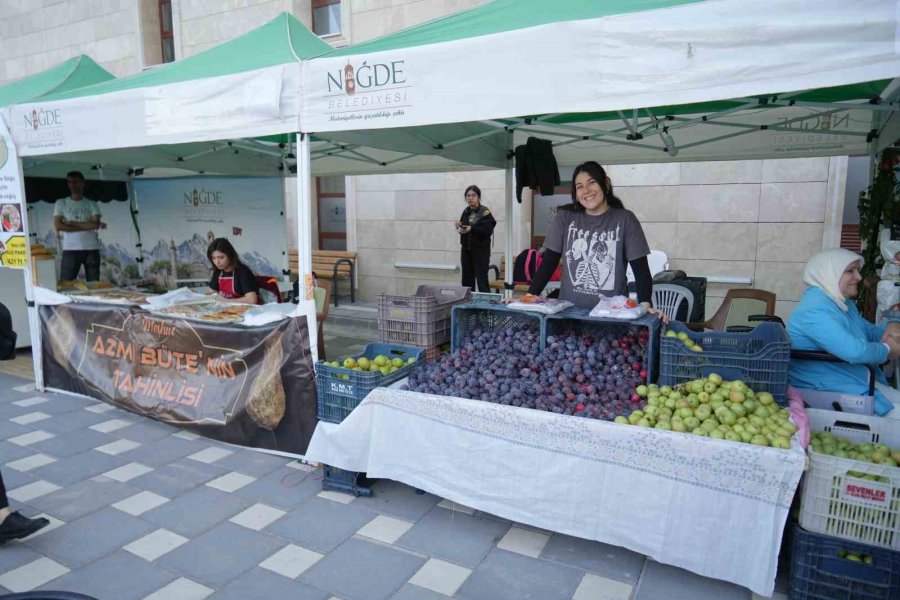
[0,54,115,106]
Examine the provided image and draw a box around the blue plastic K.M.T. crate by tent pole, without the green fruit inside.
[316,343,425,423]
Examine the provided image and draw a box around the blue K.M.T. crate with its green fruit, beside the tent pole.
[316,343,425,423]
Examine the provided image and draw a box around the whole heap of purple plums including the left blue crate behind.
[409,305,644,421]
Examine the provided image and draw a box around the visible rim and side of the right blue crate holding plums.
[541,308,662,383]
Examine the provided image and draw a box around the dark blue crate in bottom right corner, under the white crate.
[790,524,900,600]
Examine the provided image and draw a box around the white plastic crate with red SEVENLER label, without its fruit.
[800,409,900,550]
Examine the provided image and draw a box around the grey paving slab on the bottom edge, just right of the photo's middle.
[456,549,584,600]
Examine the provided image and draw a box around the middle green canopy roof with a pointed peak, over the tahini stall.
[42,12,331,100]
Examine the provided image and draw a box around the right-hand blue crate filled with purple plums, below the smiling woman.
[541,309,661,420]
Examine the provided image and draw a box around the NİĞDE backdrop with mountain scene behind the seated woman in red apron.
[134,177,287,288]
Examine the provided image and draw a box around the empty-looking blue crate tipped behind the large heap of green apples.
[659,321,791,406]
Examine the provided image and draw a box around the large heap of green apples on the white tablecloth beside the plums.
[615,373,797,450]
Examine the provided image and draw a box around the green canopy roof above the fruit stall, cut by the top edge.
[327,0,702,56]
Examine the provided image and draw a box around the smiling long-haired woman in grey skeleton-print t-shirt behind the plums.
[528,161,656,313]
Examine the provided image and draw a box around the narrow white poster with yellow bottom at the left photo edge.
[0,118,28,269]
